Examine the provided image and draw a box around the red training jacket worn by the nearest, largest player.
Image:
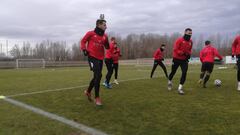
[81,31,108,60]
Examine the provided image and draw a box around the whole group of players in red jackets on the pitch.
[80,16,240,106]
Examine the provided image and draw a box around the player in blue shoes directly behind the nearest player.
[103,37,116,89]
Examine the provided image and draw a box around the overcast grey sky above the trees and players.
[0,0,240,41]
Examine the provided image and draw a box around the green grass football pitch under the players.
[0,65,240,135]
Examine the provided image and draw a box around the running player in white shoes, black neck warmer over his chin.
[168,28,193,95]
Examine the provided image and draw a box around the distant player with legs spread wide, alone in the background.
[150,44,168,78]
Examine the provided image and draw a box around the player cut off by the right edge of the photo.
[232,34,240,91]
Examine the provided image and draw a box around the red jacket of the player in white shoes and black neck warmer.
[173,37,193,60]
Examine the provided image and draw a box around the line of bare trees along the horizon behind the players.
[5,33,234,61]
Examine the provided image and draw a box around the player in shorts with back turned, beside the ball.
[198,41,222,88]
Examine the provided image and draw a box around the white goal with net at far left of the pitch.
[16,59,46,69]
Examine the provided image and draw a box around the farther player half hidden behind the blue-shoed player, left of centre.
[113,43,122,84]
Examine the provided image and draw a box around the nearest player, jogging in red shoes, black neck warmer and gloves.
[81,15,109,106]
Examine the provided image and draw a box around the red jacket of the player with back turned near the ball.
[200,45,222,63]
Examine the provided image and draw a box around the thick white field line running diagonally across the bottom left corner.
[1,96,107,135]
